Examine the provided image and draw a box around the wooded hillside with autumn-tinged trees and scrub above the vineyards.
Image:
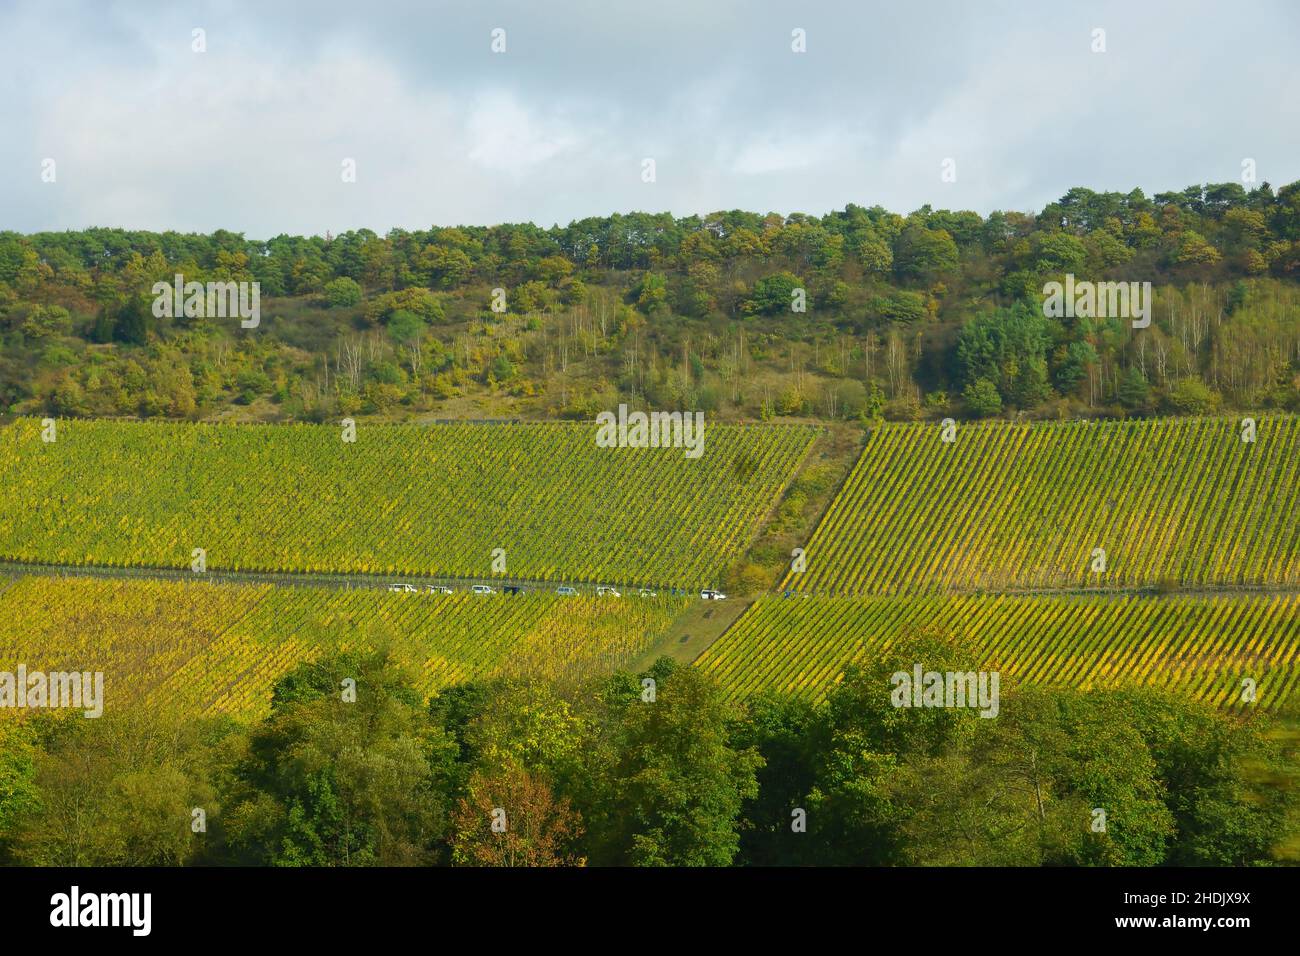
[0,182,1300,420]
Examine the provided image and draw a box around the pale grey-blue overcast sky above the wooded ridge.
[0,0,1300,238]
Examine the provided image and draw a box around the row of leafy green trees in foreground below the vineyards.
[0,631,1300,866]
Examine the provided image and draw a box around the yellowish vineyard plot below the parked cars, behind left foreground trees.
[0,576,685,718]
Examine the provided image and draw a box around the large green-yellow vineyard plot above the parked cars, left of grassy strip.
[0,419,816,588]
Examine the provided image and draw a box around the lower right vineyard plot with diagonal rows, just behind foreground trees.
[696,594,1300,710]
